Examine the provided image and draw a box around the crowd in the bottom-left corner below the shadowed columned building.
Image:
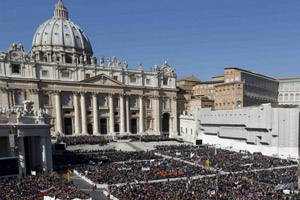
[0,172,89,200]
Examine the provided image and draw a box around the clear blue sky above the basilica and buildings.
[0,0,300,81]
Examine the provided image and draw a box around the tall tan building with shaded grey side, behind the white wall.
[214,67,278,110]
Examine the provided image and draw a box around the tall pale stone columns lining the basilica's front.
[54,92,177,135]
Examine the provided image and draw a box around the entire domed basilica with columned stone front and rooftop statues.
[0,0,178,137]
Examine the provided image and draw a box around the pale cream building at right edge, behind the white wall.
[277,77,300,107]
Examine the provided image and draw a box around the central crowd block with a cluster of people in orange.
[75,159,213,184]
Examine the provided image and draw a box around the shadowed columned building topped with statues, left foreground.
[0,101,52,178]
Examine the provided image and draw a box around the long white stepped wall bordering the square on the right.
[196,104,299,157]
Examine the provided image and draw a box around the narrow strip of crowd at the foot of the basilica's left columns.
[60,135,109,146]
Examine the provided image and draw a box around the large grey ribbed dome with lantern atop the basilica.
[32,0,93,63]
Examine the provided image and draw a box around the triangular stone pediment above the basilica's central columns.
[80,74,124,86]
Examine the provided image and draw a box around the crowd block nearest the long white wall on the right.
[156,145,297,172]
